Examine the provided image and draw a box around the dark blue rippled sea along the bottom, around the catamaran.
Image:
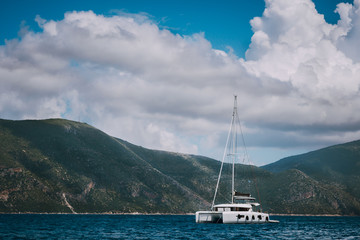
[0,214,360,239]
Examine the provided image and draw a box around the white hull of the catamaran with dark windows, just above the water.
[195,211,273,223]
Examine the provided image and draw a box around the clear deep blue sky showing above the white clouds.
[0,0,352,57]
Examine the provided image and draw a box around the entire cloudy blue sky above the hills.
[0,0,360,166]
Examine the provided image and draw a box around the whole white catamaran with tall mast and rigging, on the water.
[195,96,278,223]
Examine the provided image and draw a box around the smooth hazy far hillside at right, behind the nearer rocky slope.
[262,141,360,199]
